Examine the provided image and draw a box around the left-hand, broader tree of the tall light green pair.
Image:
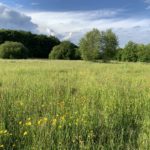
[79,29,100,61]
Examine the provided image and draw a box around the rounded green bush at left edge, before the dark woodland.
[0,41,28,59]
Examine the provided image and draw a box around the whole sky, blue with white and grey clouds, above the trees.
[0,0,150,47]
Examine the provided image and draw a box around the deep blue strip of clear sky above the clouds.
[2,0,149,12]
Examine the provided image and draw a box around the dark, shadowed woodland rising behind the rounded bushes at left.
[0,30,60,58]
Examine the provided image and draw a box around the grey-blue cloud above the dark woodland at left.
[0,3,37,32]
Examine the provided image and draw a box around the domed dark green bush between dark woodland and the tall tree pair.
[49,41,79,60]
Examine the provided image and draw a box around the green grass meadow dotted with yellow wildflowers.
[0,60,150,150]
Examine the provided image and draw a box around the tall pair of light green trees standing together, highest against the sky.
[80,29,118,61]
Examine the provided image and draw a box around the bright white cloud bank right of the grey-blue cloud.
[24,10,150,46]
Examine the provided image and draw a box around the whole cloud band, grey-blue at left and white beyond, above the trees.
[0,0,150,46]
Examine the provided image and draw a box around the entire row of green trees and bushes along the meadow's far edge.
[0,29,150,62]
